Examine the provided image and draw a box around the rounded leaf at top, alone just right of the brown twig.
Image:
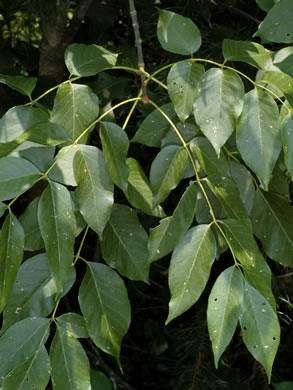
[157,9,201,56]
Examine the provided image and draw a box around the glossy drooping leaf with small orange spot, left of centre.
[73,145,113,236]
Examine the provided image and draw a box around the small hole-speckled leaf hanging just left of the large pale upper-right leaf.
[167,61,205,123]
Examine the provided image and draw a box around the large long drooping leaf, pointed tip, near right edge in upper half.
[237,89,282,188]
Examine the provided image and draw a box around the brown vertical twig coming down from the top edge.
[129,0,149,104]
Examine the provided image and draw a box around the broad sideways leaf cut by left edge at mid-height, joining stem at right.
[0,156,42,200]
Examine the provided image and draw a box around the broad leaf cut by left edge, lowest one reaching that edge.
[0,317,50,383]
